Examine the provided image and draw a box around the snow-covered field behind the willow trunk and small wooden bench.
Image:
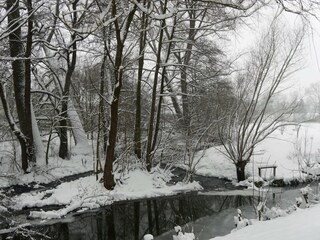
[196,123,320,180]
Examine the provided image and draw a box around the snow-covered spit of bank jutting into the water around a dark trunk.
[9,167,202,219]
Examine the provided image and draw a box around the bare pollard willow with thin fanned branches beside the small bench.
[219,22,303,181]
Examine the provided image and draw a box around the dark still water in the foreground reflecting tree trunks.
[0,194,252,240]
